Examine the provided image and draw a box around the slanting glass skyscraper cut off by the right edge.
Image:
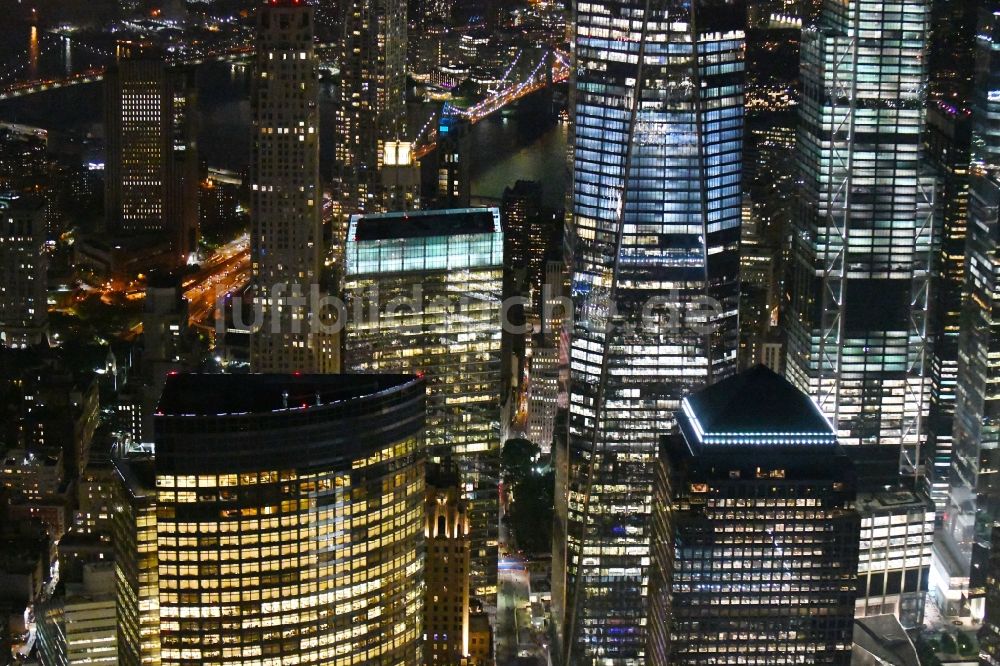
[931,3,1000,618]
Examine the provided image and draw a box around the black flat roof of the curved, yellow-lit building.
[157,373,417,416]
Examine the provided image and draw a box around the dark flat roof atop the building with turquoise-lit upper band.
[355,208,496,241]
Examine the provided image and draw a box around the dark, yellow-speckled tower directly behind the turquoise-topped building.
[334,0,416,215]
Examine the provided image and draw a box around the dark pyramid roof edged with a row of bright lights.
[687,365,834,435]
